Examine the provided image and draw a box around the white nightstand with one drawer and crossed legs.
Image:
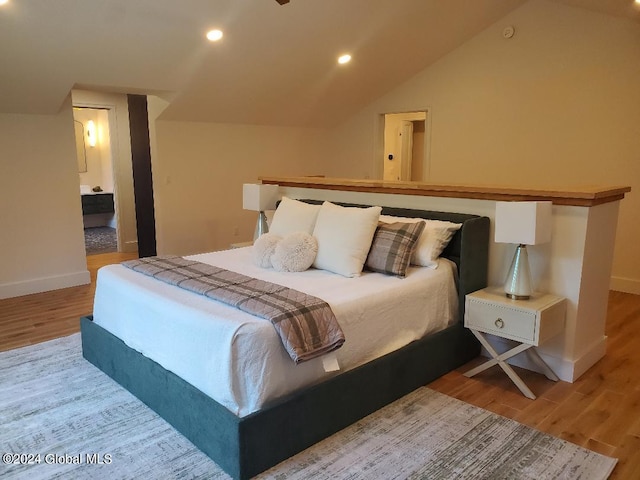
[464,287,566,400]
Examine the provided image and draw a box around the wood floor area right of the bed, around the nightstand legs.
[429,292,640,480]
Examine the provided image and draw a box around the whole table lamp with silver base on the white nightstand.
[495,202,551,300]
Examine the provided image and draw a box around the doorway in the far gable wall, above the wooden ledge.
[382,110,428,182]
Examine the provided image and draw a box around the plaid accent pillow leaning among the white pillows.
[365,222,425,277]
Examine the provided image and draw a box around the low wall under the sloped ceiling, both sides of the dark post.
[0,90,326,297]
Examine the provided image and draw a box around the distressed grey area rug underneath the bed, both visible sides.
[0,334,616,480]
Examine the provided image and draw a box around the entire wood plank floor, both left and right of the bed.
[0,254,640,480]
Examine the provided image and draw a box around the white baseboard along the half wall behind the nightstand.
[482,336,607,383]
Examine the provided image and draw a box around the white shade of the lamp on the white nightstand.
[495,202,551,245]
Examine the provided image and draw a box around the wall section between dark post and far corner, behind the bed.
[150,119,323,255]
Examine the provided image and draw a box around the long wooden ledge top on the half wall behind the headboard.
[260,176,631,207]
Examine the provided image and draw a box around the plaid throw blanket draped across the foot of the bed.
[122,256,344,364]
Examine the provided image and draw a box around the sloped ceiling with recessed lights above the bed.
[0,0,640,126]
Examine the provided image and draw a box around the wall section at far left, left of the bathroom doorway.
[0,97,89,298]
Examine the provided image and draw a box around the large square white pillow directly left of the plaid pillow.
[313,202,382,277]
